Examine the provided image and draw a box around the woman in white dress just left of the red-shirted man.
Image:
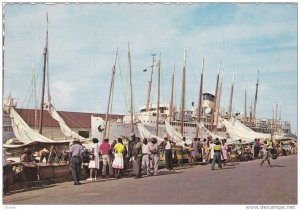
[87,138,100,181]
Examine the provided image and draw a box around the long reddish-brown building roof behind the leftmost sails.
[16,109,124,128]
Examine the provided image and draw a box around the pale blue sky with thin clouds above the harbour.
[2,3,298,133]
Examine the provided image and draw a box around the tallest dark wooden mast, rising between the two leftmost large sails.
[39,14,48,134]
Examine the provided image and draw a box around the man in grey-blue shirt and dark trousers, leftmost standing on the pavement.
[69,139,84,185]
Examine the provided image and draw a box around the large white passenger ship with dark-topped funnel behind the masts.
[91,93,291,143]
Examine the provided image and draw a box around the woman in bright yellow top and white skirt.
[112,138,125,178]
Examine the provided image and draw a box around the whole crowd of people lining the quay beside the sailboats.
[9,133,297,185]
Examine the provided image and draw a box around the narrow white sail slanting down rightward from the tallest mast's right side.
[48,102,86,141]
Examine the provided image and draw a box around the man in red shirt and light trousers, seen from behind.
[100,138,114,177]
